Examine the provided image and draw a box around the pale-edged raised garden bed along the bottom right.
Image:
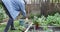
[29,25,60,32]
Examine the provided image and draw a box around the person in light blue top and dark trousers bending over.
[2,0,26,32]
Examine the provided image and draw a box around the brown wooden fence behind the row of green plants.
[26,0,60,16]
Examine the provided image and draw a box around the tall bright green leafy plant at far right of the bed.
[46,13,60,26]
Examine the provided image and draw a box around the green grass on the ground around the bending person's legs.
[0,21,21,32]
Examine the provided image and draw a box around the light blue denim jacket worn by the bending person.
[2,0,26,20]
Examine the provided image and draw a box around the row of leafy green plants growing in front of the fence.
[33,13,60,30]
